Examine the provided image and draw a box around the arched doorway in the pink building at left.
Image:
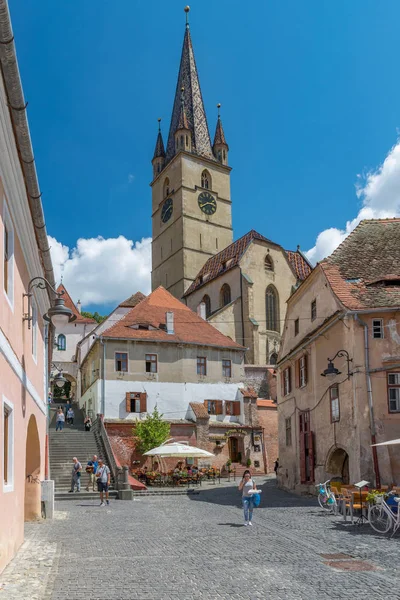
[25,415,41,521]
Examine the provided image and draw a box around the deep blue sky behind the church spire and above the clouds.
[9,0,400,310]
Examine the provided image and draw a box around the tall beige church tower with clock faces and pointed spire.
[151,7,232,299]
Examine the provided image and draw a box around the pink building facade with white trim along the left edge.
[0,0,54,572]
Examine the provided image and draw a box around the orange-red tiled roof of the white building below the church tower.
[102,286,243,350]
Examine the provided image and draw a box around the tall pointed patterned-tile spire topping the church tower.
[166,6,214,162]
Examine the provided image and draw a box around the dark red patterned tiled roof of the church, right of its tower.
[183,229,312,297]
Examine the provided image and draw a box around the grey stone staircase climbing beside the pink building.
[49,402,117,500]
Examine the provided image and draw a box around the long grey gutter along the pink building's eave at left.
[0,0,56,290]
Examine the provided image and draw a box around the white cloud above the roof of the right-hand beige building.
[306,140,400,263]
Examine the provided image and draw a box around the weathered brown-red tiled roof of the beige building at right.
[320,219,400,310]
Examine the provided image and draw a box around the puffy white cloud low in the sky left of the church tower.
[49,235,151,307]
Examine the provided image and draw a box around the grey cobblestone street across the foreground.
[0,480,400,600]
